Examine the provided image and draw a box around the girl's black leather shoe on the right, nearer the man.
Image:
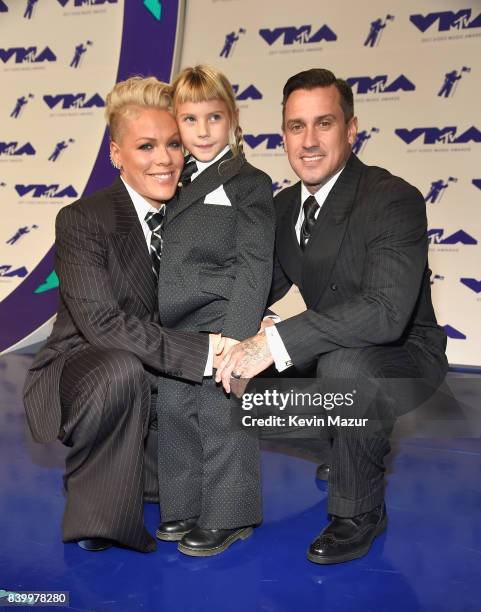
[177,527,252,557]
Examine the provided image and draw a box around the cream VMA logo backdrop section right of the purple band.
[181,0,481,366]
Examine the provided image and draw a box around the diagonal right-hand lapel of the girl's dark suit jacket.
[166,151,245,223]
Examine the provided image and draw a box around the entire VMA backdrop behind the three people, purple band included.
[0,0,481,365]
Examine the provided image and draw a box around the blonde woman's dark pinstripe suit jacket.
[24,179,208,442]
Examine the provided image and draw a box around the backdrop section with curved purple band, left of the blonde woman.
[0,0,183,352]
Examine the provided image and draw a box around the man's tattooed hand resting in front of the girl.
[215,332,274,393]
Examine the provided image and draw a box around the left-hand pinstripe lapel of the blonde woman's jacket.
[111,178,157,312]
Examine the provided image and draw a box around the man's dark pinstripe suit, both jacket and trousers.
[269,155,447,516]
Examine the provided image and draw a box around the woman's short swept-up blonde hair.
[105,76,173,140]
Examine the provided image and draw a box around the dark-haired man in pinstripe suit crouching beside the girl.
[217,69,447,564]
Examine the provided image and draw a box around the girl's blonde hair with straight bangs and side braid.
[172,64,243,155]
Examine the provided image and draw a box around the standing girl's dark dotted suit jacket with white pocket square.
[159,153,275,340]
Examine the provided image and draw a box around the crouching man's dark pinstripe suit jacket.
[269,154,446,371]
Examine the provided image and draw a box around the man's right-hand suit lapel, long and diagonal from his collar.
[301,154,362,308]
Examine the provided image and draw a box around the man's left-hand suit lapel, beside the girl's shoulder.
[276,182,302,287]
